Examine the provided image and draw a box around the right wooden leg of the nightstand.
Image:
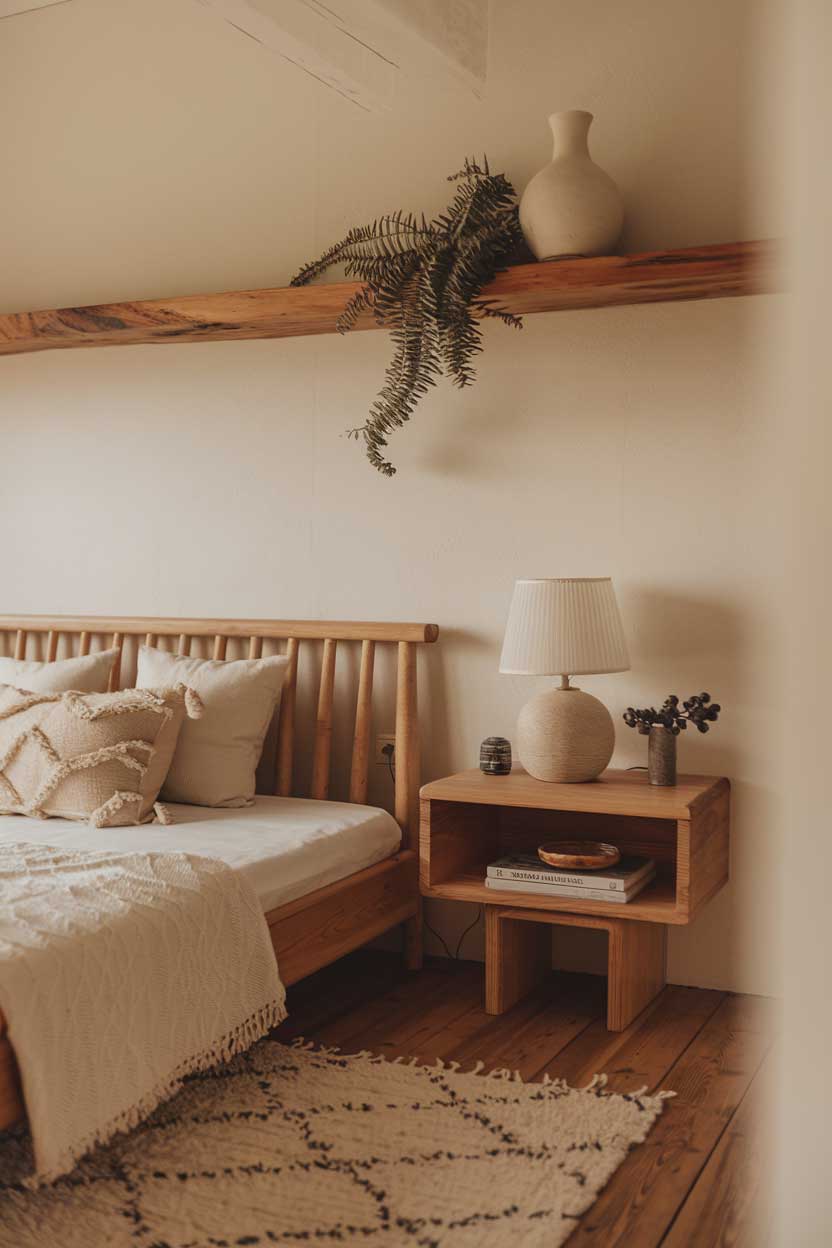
[606,920,667,1031]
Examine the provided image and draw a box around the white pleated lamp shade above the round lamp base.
[500,577,630,676]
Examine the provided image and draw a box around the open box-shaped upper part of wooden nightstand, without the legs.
[419,770,730,925]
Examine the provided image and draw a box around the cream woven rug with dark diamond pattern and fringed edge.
[0,1040,664,1248]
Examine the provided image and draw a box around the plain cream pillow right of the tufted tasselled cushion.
[136,645,289,806]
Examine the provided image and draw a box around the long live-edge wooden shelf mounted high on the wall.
[0,240,780,354]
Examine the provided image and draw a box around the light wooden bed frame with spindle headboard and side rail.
[0,615,439,1129]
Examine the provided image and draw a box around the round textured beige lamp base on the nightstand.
[516,688,615,784]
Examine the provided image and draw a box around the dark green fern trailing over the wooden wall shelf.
[292,158,523,477]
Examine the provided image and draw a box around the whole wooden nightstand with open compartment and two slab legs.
[419,770,730,1031]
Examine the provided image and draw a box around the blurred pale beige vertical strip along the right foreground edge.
[776,0,832,1248]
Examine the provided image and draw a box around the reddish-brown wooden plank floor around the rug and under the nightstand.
[277,951,775,1248]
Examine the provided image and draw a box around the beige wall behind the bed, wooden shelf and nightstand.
[0,0,787,992]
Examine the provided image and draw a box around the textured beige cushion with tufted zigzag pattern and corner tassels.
[0,685,202,827]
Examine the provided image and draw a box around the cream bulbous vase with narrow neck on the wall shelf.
[520,109,624,260]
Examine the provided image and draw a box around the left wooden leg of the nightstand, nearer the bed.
[485,906,551,1013]
